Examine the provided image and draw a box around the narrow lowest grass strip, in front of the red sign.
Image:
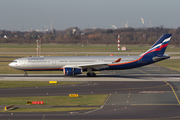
[0,107,98,112]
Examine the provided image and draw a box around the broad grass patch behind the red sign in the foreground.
[0,94,108,106]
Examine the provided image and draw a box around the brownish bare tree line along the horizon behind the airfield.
[0,26,180,47]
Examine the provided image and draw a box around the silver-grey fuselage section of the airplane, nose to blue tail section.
[9,56,140,71]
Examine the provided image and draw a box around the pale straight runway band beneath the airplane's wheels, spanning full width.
[0,74,180,81]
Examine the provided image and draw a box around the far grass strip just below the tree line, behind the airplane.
[0,44,180,52]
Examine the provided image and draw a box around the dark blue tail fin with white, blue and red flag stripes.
[142,34,171,57]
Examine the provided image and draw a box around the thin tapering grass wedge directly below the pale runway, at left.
[0,81,84,88]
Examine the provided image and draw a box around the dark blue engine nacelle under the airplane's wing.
[63,67,82,76]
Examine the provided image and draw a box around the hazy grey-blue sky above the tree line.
[0,0,180,31]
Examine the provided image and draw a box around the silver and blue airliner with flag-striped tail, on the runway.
[9,34,171,77]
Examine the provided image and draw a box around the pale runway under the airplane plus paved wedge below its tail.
[0,64,180,81]
